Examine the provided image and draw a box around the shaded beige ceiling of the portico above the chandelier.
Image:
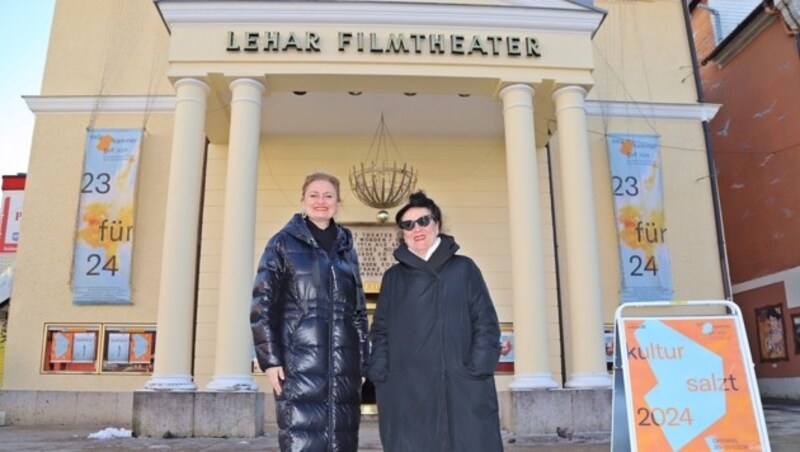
[206,78,554,144]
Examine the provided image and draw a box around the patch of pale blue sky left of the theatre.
[0,0,55,176]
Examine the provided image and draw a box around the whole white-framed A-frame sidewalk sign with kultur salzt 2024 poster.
[611,300,770,452]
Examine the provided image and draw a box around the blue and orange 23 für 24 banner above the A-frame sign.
[608,134,672,303]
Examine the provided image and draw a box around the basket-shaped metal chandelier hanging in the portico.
[350,114,417,212]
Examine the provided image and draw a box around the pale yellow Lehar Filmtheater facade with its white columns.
[0,0,725,429]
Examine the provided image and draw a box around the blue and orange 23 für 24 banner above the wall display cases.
[72,129,142,304]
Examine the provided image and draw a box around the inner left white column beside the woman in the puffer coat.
[207,78,264,391]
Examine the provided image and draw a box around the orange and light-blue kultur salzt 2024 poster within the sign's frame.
[623,318,762,451]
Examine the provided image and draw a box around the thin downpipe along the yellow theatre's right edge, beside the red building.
[681,0,733,301]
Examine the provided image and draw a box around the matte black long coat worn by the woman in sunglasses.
[368,235,503,452]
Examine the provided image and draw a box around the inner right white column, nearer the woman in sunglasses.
[500,85,559,390]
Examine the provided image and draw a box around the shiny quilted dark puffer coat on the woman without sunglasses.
[250,214,368,451]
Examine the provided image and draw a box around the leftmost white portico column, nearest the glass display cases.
[145,78,211,391]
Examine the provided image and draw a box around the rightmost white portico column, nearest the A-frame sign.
[553,86,611,388]
